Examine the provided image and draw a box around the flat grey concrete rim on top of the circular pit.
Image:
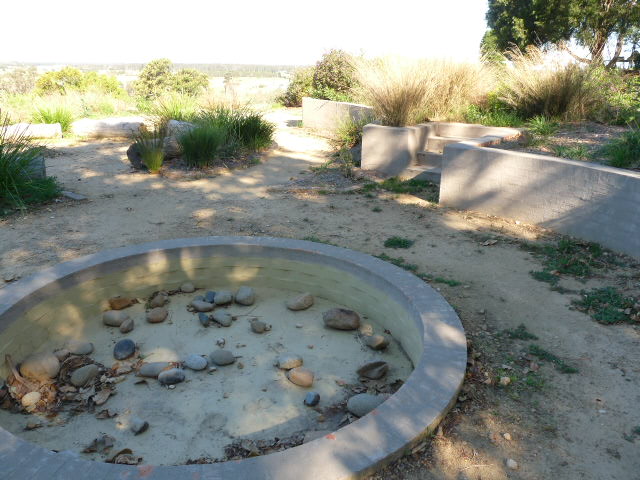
[0,237,466,480]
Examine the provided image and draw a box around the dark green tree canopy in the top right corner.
[482,0,640,65]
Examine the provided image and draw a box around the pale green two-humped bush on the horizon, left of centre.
[133,58,209,100]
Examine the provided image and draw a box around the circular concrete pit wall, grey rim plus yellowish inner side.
[0,237,466,480]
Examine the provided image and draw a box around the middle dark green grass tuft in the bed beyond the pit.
[178,122,228,167]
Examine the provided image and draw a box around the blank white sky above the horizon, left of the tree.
[0,0,487,64]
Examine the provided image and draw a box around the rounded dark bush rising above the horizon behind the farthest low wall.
[313,50,357,100]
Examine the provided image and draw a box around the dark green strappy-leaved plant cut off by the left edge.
[0,112,60,213]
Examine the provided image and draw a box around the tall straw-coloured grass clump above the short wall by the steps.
[356,57,493,126]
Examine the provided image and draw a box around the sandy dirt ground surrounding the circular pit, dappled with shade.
[0,111,640,480]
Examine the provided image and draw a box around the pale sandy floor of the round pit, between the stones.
[0,285,412,465]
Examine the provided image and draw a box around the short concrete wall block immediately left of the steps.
[361,124,422,176]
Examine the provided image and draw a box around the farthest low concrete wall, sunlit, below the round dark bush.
[302,97,373,135]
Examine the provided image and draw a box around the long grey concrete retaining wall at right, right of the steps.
[440,142,640,258]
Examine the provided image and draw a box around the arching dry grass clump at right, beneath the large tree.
[501,47,605,120]
